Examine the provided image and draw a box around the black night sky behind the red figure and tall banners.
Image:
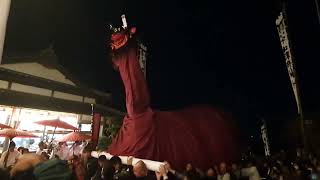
[5,0,320,149]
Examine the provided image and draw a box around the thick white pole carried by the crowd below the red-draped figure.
[91,151,164,171]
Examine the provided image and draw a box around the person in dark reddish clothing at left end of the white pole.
[82,144,99,180]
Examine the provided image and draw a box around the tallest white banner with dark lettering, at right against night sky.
[276,9,302,114]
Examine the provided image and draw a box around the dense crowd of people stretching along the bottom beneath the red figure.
[0,142,320,180]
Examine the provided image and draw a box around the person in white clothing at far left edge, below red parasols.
[0,141,21,168]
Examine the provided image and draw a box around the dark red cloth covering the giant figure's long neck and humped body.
[108,45,241,169]
